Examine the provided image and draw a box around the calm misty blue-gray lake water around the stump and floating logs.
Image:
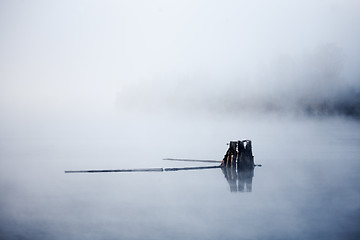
[0,114,360,239]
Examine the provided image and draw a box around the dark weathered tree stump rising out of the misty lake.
[221,140,254,169]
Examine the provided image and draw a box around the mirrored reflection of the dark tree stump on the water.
[221,166,254,192]
